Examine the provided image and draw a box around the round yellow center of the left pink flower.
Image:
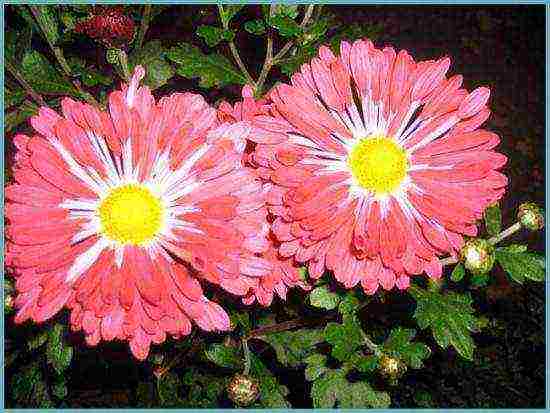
[98,184,164,245]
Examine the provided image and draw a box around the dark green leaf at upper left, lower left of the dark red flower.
[20,50,78,97]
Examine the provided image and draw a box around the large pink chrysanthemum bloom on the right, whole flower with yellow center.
[250,40,507,294]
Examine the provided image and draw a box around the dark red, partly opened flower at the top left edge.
[75,6,135,48]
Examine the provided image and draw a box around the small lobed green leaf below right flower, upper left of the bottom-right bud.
[325,316,363,361]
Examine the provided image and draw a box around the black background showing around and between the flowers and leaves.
[6,5,545,408]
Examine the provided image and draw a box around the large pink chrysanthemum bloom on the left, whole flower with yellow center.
[5,67,272,359]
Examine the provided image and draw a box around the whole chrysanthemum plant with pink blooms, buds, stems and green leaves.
[4,5,545,408]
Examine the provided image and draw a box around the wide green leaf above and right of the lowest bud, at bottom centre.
[262,328,324,367]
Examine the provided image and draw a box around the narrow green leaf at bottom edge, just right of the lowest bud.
[250,353,291,408]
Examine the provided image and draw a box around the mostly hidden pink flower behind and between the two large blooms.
[218,85,310,306]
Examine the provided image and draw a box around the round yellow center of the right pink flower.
[348,135,409,195]
